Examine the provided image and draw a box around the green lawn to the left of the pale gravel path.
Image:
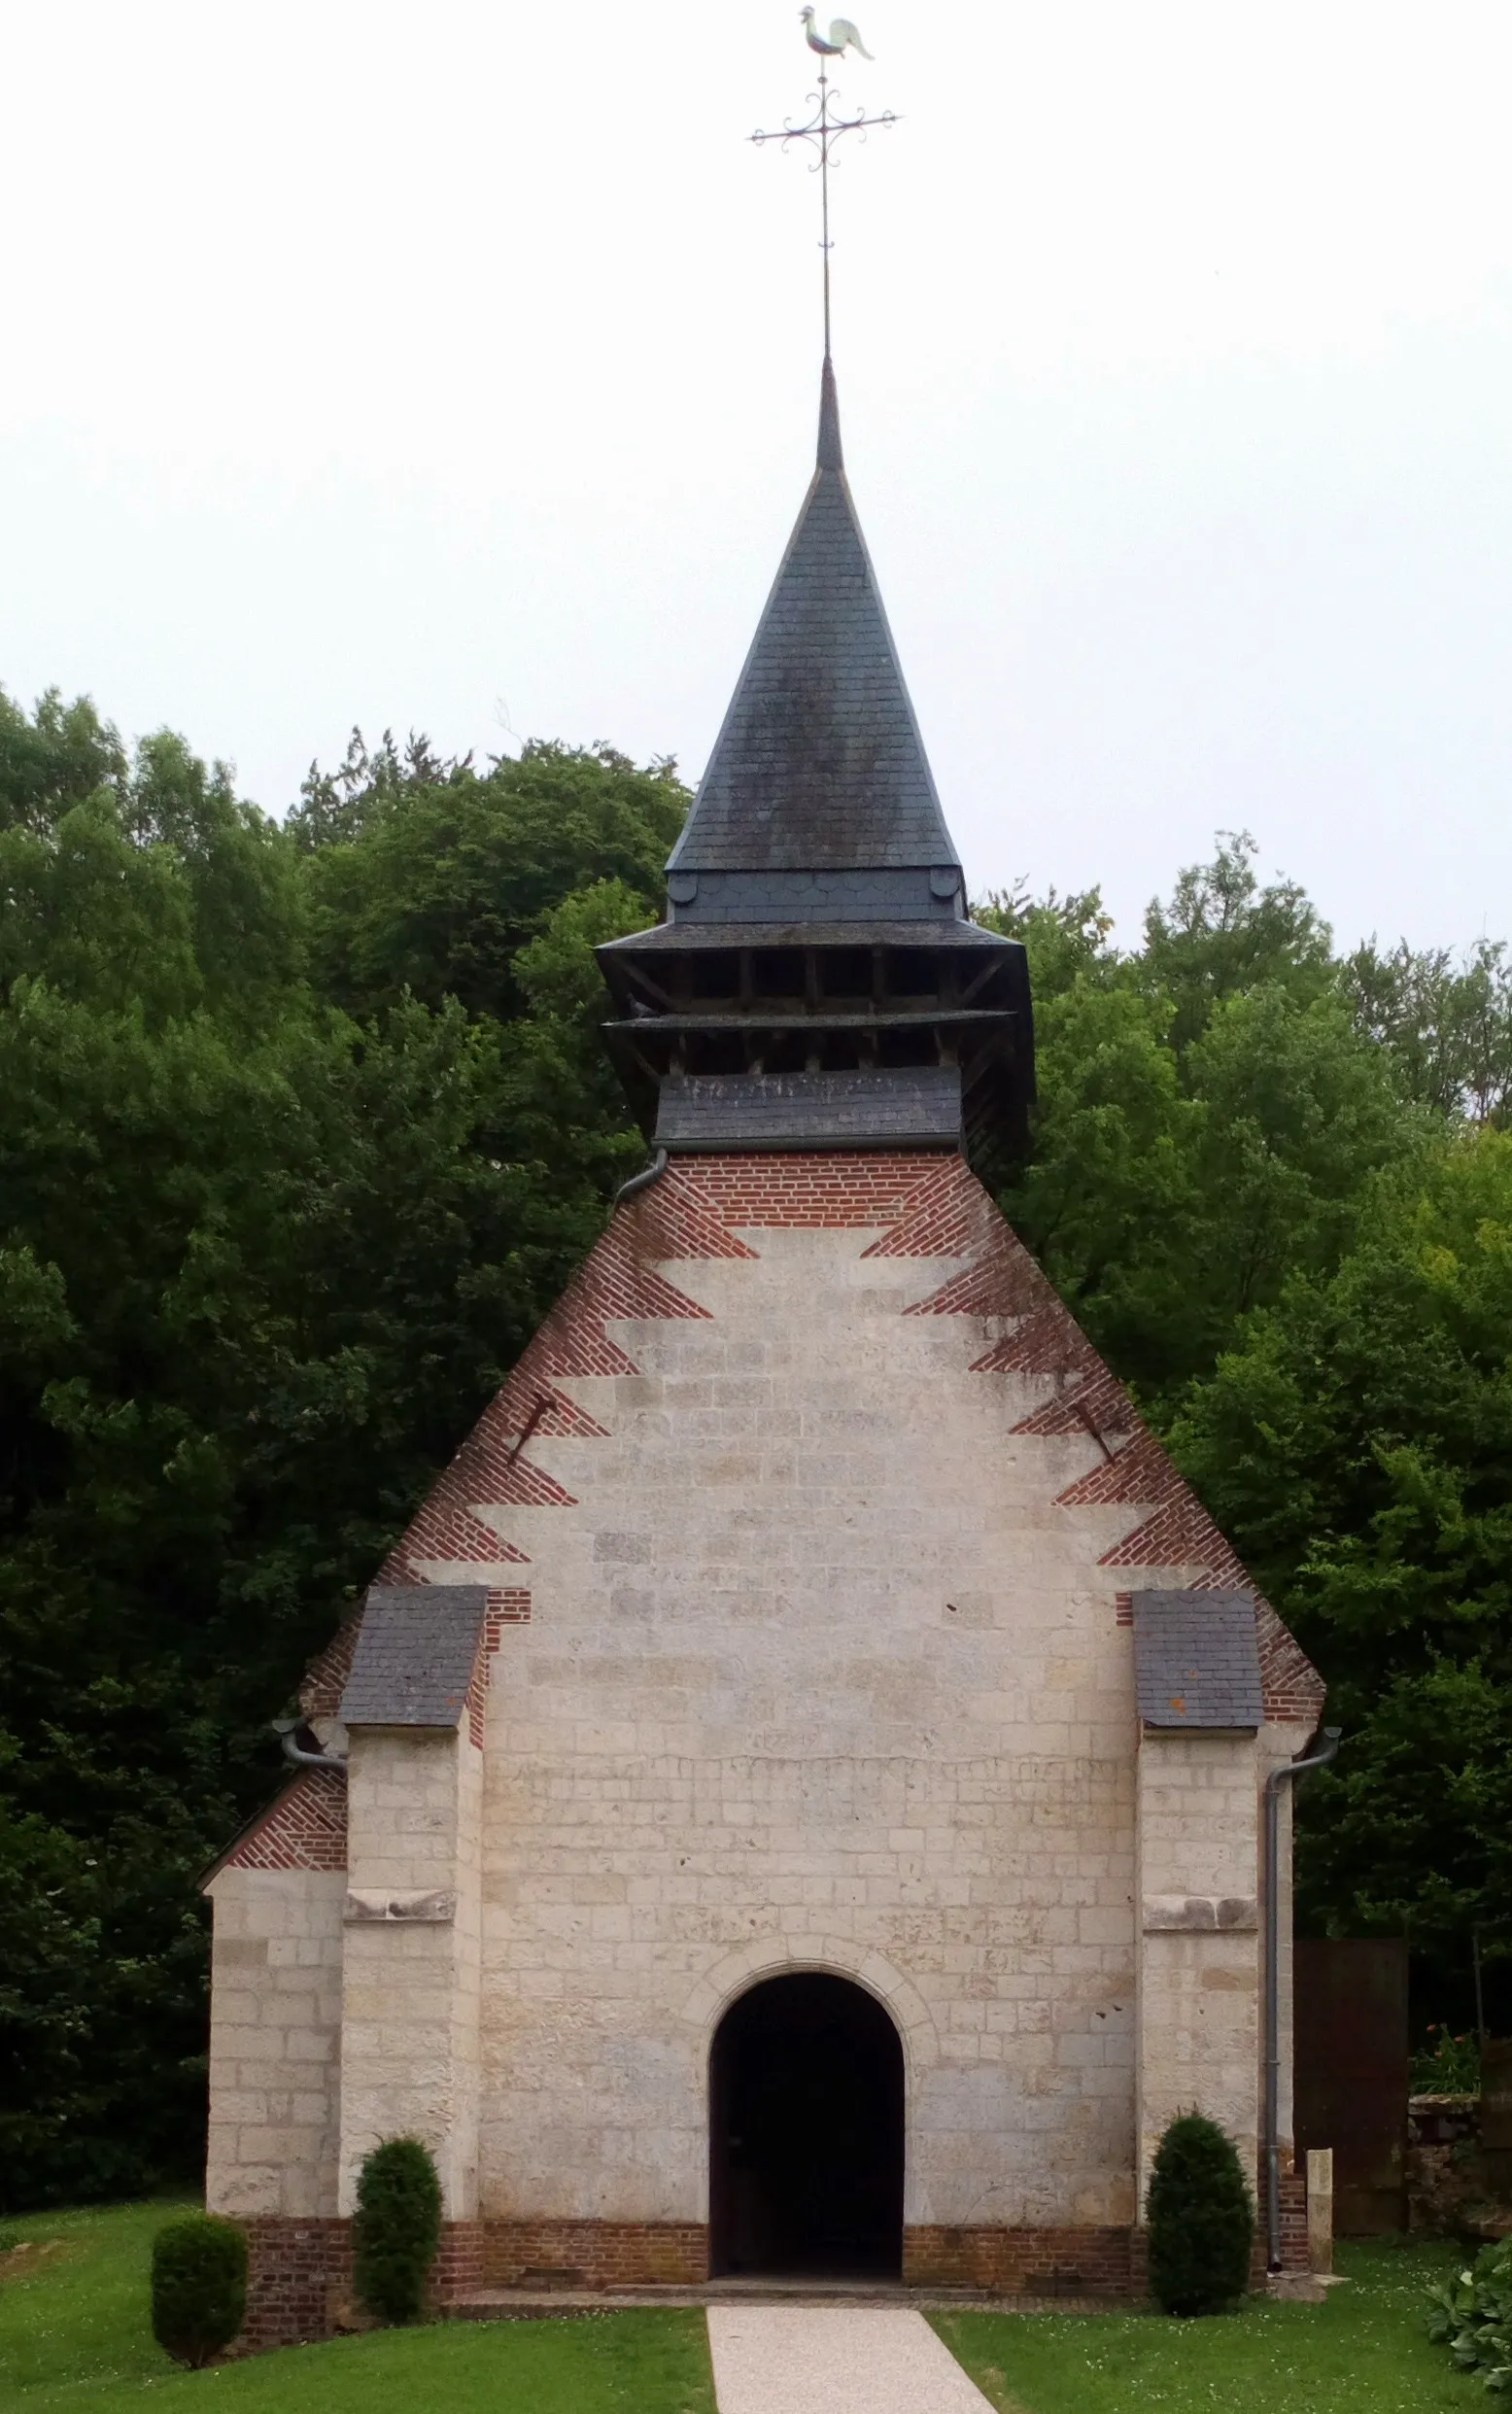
[0,2204,715,2414]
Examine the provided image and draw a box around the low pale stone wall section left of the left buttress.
[205,1869,345,2216]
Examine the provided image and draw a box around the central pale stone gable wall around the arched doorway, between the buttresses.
[459,1228,1140,2225]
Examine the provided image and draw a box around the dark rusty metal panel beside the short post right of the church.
[1292,1936,1408,2238]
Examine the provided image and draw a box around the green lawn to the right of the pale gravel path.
[935,2243,1497,2414]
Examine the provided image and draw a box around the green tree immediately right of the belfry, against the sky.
[983,859,1421,1420]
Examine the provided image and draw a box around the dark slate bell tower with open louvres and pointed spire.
[599,358,1034,1161]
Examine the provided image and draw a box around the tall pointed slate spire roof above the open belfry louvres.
[667,360,959,872]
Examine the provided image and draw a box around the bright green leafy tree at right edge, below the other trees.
[1172,1127,1512,2017]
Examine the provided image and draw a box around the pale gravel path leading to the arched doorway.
[707,2305,993,2414]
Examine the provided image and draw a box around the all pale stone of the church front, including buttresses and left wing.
[210,1197,1304,2228]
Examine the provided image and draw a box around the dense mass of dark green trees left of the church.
[0,698,681,2201]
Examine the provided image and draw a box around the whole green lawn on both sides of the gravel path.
[0,2204,1491,2414]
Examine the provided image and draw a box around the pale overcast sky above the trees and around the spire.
[0,0,1512,944]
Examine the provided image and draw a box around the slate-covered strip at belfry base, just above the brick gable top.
[655,1064,961,1149]
